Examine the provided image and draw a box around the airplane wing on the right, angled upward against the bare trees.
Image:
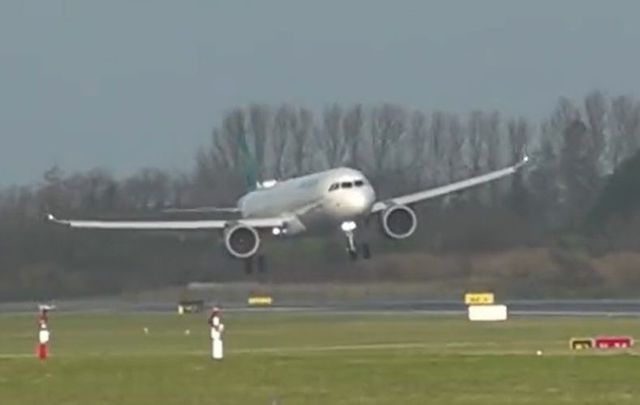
[371,155,529,213]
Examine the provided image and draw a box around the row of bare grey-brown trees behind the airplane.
[0,91,640,298]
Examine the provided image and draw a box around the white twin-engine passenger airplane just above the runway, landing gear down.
[47,154,529,273]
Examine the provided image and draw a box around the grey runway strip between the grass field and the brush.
[0,299,640,317]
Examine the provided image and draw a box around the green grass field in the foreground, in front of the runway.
[0,312,640,405]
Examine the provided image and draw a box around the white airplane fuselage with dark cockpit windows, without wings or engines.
[238,168,376,235]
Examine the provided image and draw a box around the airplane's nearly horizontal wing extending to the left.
[47,214,286,231]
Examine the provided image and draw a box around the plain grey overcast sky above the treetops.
[0,0,640,185]
